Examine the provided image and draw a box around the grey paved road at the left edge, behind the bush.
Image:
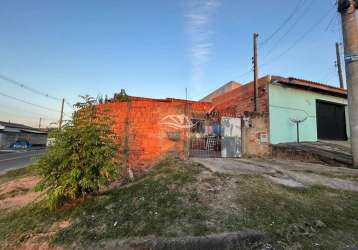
[0,149,45,173]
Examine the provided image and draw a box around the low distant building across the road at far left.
[0,121,47,149]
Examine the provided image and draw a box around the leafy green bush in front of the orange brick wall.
[37,96,120,208]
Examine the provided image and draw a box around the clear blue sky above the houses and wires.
[0,0,341,125]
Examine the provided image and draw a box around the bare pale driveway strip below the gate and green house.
[191,158,358,191]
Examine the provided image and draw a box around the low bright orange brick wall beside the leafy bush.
[101,97,211,170]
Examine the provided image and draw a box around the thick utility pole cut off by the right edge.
[338,0,358,167]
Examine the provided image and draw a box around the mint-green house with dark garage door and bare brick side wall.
[207,76,350,155]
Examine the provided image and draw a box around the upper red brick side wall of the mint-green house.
[213,76,269,116]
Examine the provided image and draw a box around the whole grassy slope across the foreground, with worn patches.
[0,159,358,249]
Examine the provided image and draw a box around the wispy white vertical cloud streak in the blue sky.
[186,0,220,90]
